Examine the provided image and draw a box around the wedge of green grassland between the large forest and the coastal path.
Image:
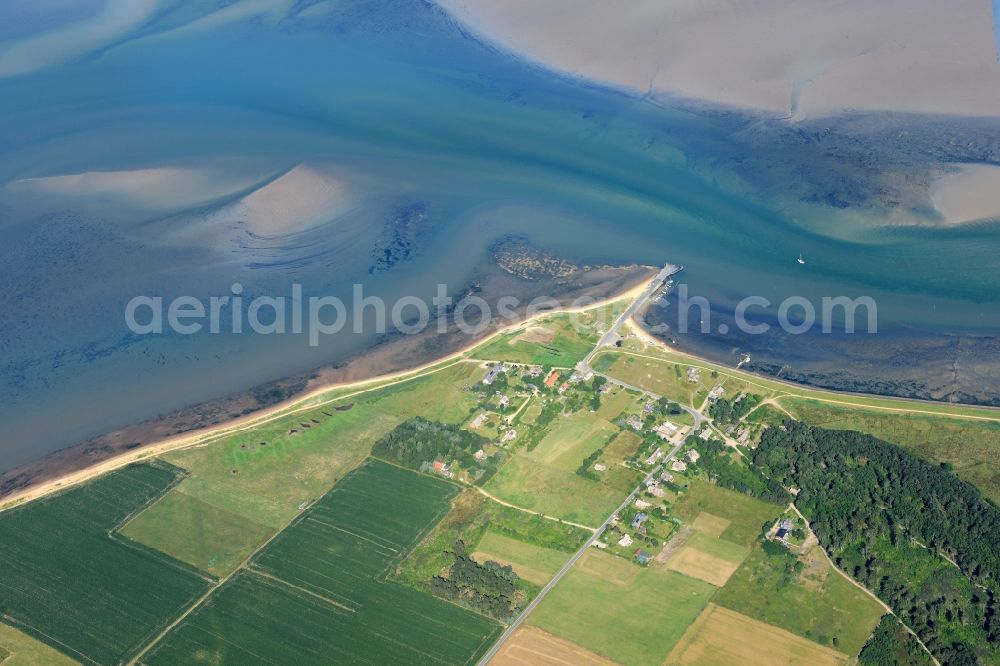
[779,397,1000,504]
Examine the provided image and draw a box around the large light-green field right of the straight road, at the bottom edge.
[528,550,716,666]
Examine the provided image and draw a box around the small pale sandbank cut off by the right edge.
[931,164,1000,224]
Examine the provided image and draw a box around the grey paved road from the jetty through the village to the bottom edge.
[479,264,701,666]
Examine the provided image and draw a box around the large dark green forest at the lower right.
[753,421,1000,664]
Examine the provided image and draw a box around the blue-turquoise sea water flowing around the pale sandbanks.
[0,2,1000,470]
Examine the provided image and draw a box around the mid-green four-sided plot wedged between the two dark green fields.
[120,488,276,577]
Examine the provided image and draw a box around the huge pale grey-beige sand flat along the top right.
[437,0,1000,119]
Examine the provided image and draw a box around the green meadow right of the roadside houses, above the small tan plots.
[673,479,785,546]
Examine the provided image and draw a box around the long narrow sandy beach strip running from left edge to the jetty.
[0,266,656,512]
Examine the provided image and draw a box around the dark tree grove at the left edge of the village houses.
[372,416,496,483]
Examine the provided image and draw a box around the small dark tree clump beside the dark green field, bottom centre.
[431,539,524,620]
